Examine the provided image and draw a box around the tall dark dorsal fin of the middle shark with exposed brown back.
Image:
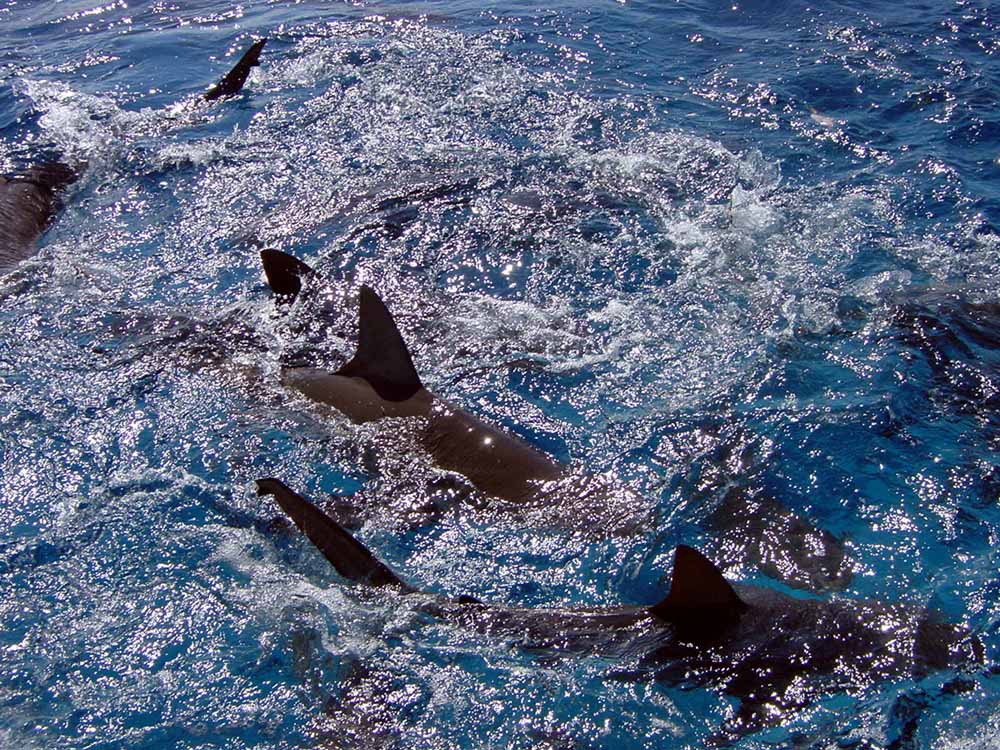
[337,286,423,401]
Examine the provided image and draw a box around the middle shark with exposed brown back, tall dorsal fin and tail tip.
[261,250,650,534]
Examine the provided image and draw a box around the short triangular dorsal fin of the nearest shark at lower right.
[650,544,746,625]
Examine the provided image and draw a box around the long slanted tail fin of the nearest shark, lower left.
[257,479,415,592]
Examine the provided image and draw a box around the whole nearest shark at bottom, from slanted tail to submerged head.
[257,478,984,737]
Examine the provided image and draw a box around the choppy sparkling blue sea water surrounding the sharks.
[0,0,1000,748]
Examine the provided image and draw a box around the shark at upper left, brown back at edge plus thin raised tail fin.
[0,38,267,276]
